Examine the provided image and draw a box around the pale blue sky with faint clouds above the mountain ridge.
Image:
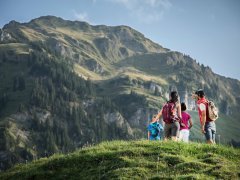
[0,0,240,80]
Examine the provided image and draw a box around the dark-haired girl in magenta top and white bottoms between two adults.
[178,102,193,143]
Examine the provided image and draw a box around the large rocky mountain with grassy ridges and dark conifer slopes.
[0,16,240,169]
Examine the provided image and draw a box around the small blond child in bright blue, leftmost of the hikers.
[147,115,163,140]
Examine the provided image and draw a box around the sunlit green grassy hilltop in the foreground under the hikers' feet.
[0,141,240,179]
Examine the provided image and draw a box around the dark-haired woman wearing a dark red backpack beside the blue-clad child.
[156,91,182,141]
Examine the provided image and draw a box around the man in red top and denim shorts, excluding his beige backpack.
[193,89,216,144]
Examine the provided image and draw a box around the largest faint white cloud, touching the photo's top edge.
[107,0,172,24]
